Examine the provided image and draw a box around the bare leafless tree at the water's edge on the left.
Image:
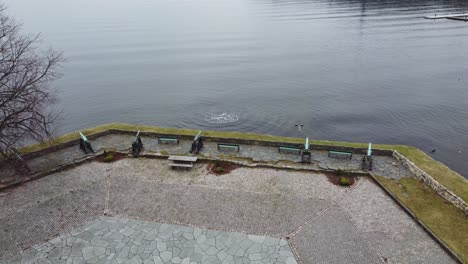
[0,5,63,160]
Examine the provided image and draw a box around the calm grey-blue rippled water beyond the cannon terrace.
[6,0,468,177]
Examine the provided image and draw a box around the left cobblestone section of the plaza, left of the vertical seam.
[0,166,106,259]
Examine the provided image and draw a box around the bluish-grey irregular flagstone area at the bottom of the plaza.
[5,217,297,264]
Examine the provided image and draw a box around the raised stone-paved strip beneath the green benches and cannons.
[0,134,412,184]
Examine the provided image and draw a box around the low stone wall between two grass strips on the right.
[393,151,468,215]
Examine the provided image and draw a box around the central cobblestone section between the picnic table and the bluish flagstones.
[109,164,330,236]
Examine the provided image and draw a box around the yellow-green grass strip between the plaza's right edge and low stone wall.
[376,176,468,263]
